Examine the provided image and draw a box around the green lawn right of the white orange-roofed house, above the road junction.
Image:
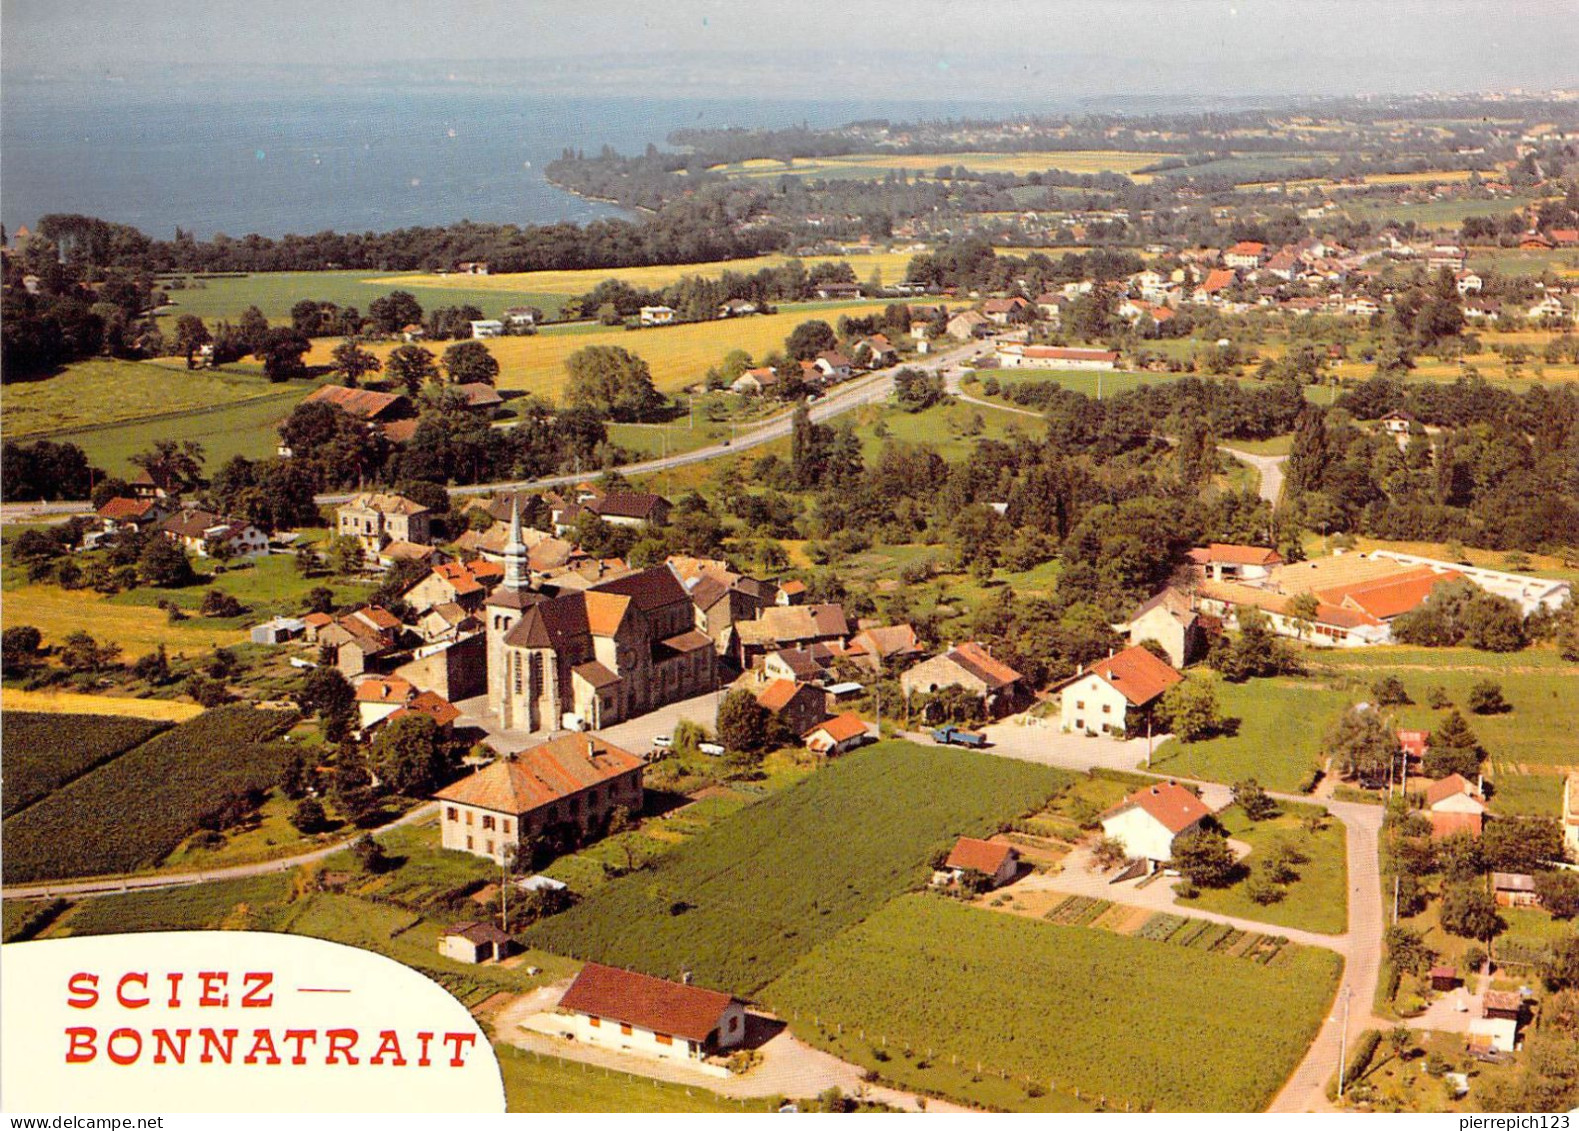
[1151,670,1361,793]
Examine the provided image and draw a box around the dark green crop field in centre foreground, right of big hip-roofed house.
[527,742,1069,992]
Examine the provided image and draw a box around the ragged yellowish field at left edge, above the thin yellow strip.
[0,584,246,660]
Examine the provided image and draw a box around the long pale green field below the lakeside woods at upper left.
[161,270,571,325]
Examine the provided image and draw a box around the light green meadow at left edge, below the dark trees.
[5,357,298,439]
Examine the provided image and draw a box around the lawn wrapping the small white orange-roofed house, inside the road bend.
[1184,802,1348,935]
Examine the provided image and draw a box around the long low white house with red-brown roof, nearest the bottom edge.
[559,962,745,1074]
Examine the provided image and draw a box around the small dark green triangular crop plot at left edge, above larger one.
[0,711,167,817]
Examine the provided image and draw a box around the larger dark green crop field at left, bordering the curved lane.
[0,705,295,883]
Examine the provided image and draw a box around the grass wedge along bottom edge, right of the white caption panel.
[494,1043,775,1114]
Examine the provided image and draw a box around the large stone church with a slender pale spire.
[485,495,718,731]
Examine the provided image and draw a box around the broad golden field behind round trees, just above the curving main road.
[306,302,886,400]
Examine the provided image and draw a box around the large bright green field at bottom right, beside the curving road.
[763,896,1342,1112]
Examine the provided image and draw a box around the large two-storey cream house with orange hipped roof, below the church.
[433,735,643,862]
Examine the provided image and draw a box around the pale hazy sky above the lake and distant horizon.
[0,0,1579,101]
